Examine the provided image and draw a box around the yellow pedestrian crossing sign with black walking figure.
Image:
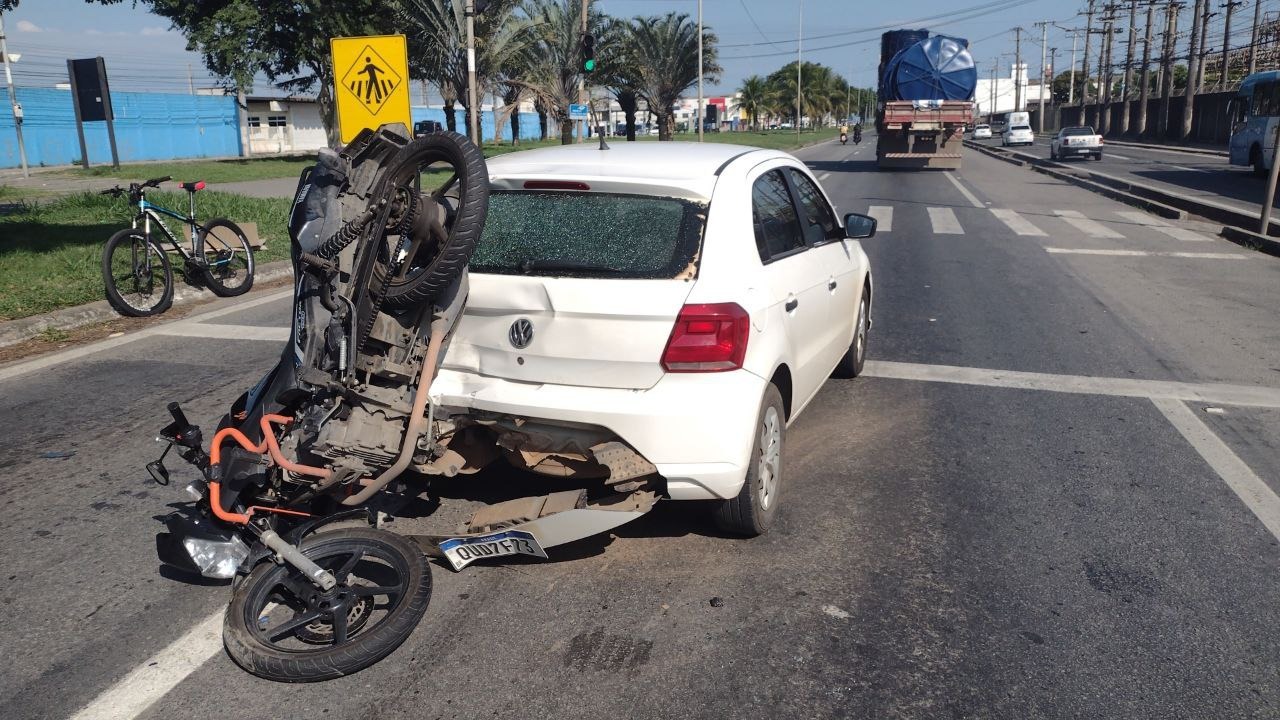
[329,35,413,142]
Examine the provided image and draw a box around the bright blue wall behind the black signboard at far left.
[0,87,241,168]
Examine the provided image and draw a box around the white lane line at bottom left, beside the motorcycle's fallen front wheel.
[70,610,223,720]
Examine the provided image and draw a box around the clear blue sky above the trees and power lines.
[5,0,1105,100]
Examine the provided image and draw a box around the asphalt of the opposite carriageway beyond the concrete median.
[979,133,1267,213]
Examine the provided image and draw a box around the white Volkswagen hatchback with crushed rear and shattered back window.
[431,142,876,534]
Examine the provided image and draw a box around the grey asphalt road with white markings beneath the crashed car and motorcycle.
[0,137,1280,720]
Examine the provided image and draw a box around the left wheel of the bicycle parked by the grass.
[102,228,173,318]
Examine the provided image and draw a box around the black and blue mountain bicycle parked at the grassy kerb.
[102,176,253,318]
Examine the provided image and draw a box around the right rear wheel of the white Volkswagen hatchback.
[716,384,787,537]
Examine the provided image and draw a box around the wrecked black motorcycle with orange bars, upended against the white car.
[147,126,657,682]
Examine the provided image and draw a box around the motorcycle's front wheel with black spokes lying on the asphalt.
[223,528,431,683]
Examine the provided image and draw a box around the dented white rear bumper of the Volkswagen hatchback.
[431,370,767,500]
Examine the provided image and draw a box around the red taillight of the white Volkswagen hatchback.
[662,302,751,373]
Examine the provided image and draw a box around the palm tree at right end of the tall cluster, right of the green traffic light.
[628,13,721,140]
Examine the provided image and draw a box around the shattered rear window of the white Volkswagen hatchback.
[471,191,707,278]
